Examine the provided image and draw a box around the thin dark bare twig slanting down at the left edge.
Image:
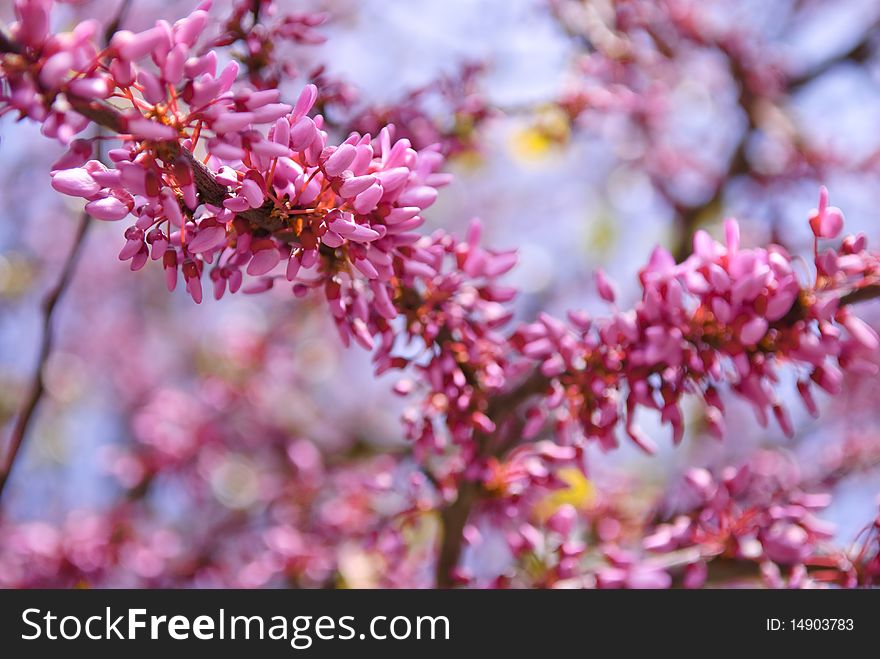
[0,213,90,498]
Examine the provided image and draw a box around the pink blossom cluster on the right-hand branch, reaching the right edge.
[514,190,880,453]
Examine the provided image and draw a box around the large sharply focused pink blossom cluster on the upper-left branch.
[8,2,448,330]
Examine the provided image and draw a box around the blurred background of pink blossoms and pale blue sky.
[0,0,880,586]
